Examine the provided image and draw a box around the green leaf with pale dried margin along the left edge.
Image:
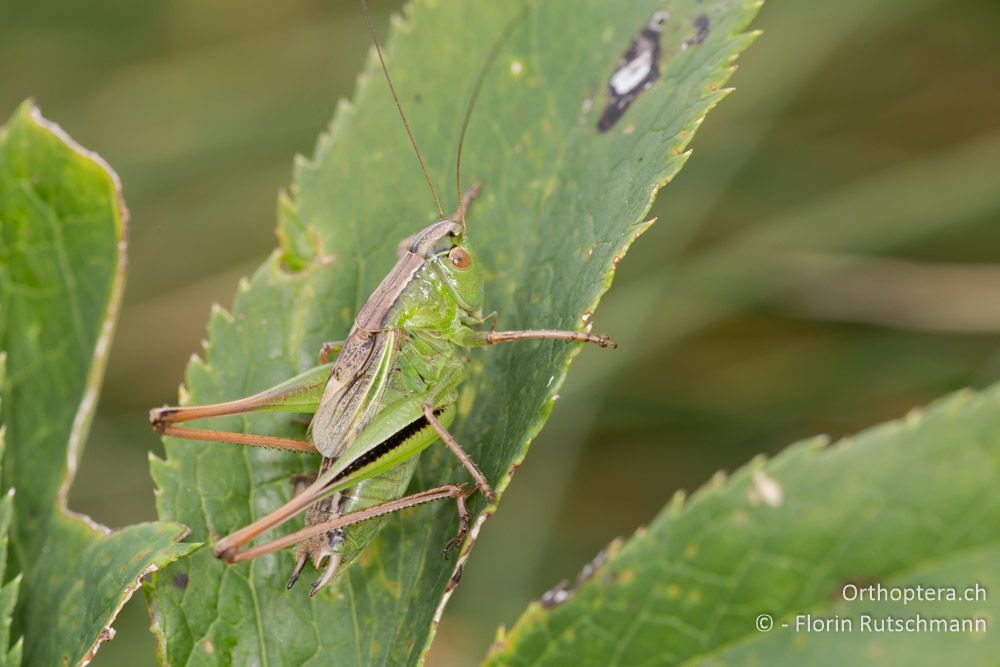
[0,103,197,665]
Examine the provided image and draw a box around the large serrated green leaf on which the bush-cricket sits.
[147,0,758,665]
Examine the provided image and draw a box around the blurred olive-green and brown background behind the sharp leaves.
[0,0,1000,665]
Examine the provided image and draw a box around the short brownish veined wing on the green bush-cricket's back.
[309,328,398,458]
